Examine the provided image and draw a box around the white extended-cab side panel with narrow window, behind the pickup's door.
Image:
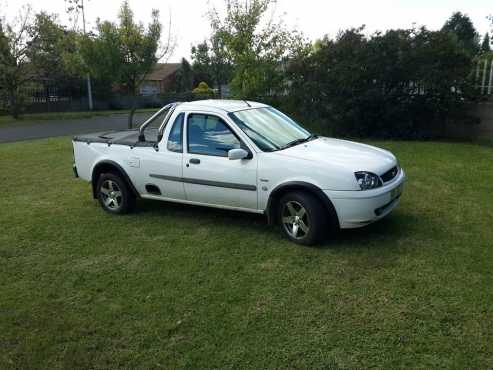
[136,113,185,200]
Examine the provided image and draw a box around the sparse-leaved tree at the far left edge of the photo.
[0,6,37,118]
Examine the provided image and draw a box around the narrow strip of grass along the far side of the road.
[0,108,157,127]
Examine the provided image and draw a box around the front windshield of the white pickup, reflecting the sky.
[229,107,315,152]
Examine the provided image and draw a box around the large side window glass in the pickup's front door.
[187,113,241,157]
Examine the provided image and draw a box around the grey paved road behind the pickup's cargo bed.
[0,112,152,143]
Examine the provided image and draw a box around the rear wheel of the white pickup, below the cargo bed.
[96,173,135,214]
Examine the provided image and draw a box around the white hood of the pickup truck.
[277,137,397,175]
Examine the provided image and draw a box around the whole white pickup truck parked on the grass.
[73,100,405,245]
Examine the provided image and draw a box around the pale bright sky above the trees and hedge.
[0,0,493,62]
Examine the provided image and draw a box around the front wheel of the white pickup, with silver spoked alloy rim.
[278,191,331,245]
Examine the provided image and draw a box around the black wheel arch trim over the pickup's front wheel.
[265,181,339,227]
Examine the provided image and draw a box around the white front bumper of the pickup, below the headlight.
[324,169,406,229]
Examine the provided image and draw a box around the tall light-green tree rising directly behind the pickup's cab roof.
[209,0,303,99]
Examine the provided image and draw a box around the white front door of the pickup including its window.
[183,113,257,210]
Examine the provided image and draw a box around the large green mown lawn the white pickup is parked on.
[0,138,493,369]
